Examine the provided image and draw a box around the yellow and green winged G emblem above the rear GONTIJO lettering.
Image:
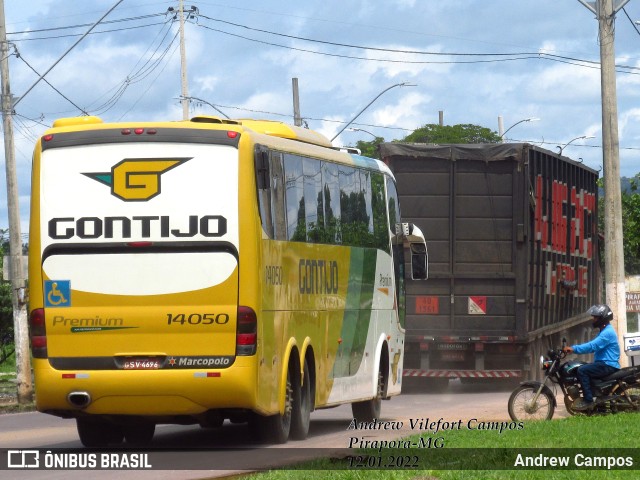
[83,157,193,202]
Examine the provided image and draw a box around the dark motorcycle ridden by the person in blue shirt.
[509,339,640,421]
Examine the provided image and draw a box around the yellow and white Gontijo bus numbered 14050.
[29,117,427,447]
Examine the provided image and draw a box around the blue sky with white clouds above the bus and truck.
[0,0,640,237]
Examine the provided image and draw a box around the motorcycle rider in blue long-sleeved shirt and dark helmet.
[563,305,620,411]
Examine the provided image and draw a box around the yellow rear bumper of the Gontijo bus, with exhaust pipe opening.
[35,362,257,417]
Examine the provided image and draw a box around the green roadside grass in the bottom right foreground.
[248,413,640,480]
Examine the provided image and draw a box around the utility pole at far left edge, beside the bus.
[0,0,33,404]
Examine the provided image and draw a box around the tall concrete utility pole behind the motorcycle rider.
[578,0,630,367]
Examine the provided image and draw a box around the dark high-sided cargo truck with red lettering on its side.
[380,143,602,387]
